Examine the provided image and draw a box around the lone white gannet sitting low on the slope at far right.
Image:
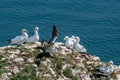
[100,61,114,73]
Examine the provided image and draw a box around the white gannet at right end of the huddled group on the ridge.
[75,37,87,52]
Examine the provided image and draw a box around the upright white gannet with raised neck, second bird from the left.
[27,27,39,43]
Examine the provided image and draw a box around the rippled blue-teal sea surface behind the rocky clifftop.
[0,0,120,65]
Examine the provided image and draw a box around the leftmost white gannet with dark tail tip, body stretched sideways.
[7,29,28,45]
